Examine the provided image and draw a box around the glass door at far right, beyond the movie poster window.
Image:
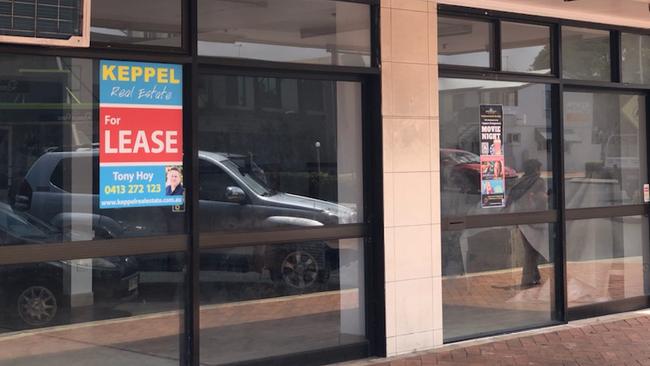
[563,90,648,318]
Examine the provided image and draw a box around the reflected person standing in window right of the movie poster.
[508,159,549,287]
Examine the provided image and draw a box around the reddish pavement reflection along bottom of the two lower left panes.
[0,289,363,366]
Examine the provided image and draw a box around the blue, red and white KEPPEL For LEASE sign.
[99,60,185,208]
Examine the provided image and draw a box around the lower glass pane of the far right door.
[566,216,650,307]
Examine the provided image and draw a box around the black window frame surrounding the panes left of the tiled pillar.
[0,0,386,366]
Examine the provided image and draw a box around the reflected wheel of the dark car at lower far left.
[16,285,59,327]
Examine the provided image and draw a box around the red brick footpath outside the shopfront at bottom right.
[337,309,650,366]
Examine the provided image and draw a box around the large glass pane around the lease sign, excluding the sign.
[0,55,185,245]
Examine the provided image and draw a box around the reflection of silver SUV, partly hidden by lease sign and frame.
[15,150,356,289]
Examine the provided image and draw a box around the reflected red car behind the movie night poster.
[440,149,517,193]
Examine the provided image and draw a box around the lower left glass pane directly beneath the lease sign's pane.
[0,253,185,366]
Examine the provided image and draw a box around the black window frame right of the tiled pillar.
[438,4,650,342]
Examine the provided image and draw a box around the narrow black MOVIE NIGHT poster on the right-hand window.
[479,104,506,208]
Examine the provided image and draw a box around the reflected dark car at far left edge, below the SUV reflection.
[0,205,139,327]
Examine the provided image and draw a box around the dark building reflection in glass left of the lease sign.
[0,56,94,200]
